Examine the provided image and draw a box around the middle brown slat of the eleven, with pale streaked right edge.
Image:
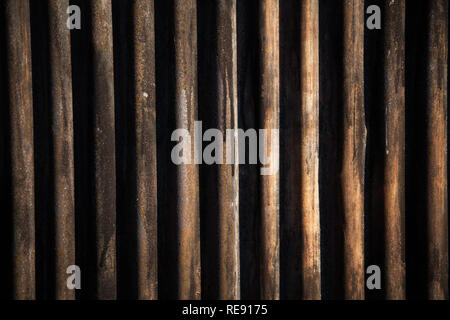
[216,0,240,300]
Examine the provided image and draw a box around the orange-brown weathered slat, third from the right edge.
[340,0,366,299]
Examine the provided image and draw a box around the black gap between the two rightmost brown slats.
[405,1,429,299]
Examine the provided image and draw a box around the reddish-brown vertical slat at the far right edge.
[426,0,448,299]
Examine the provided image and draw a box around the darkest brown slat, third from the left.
[90,0,117,300]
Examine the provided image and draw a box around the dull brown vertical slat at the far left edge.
[5,0,36,300]
